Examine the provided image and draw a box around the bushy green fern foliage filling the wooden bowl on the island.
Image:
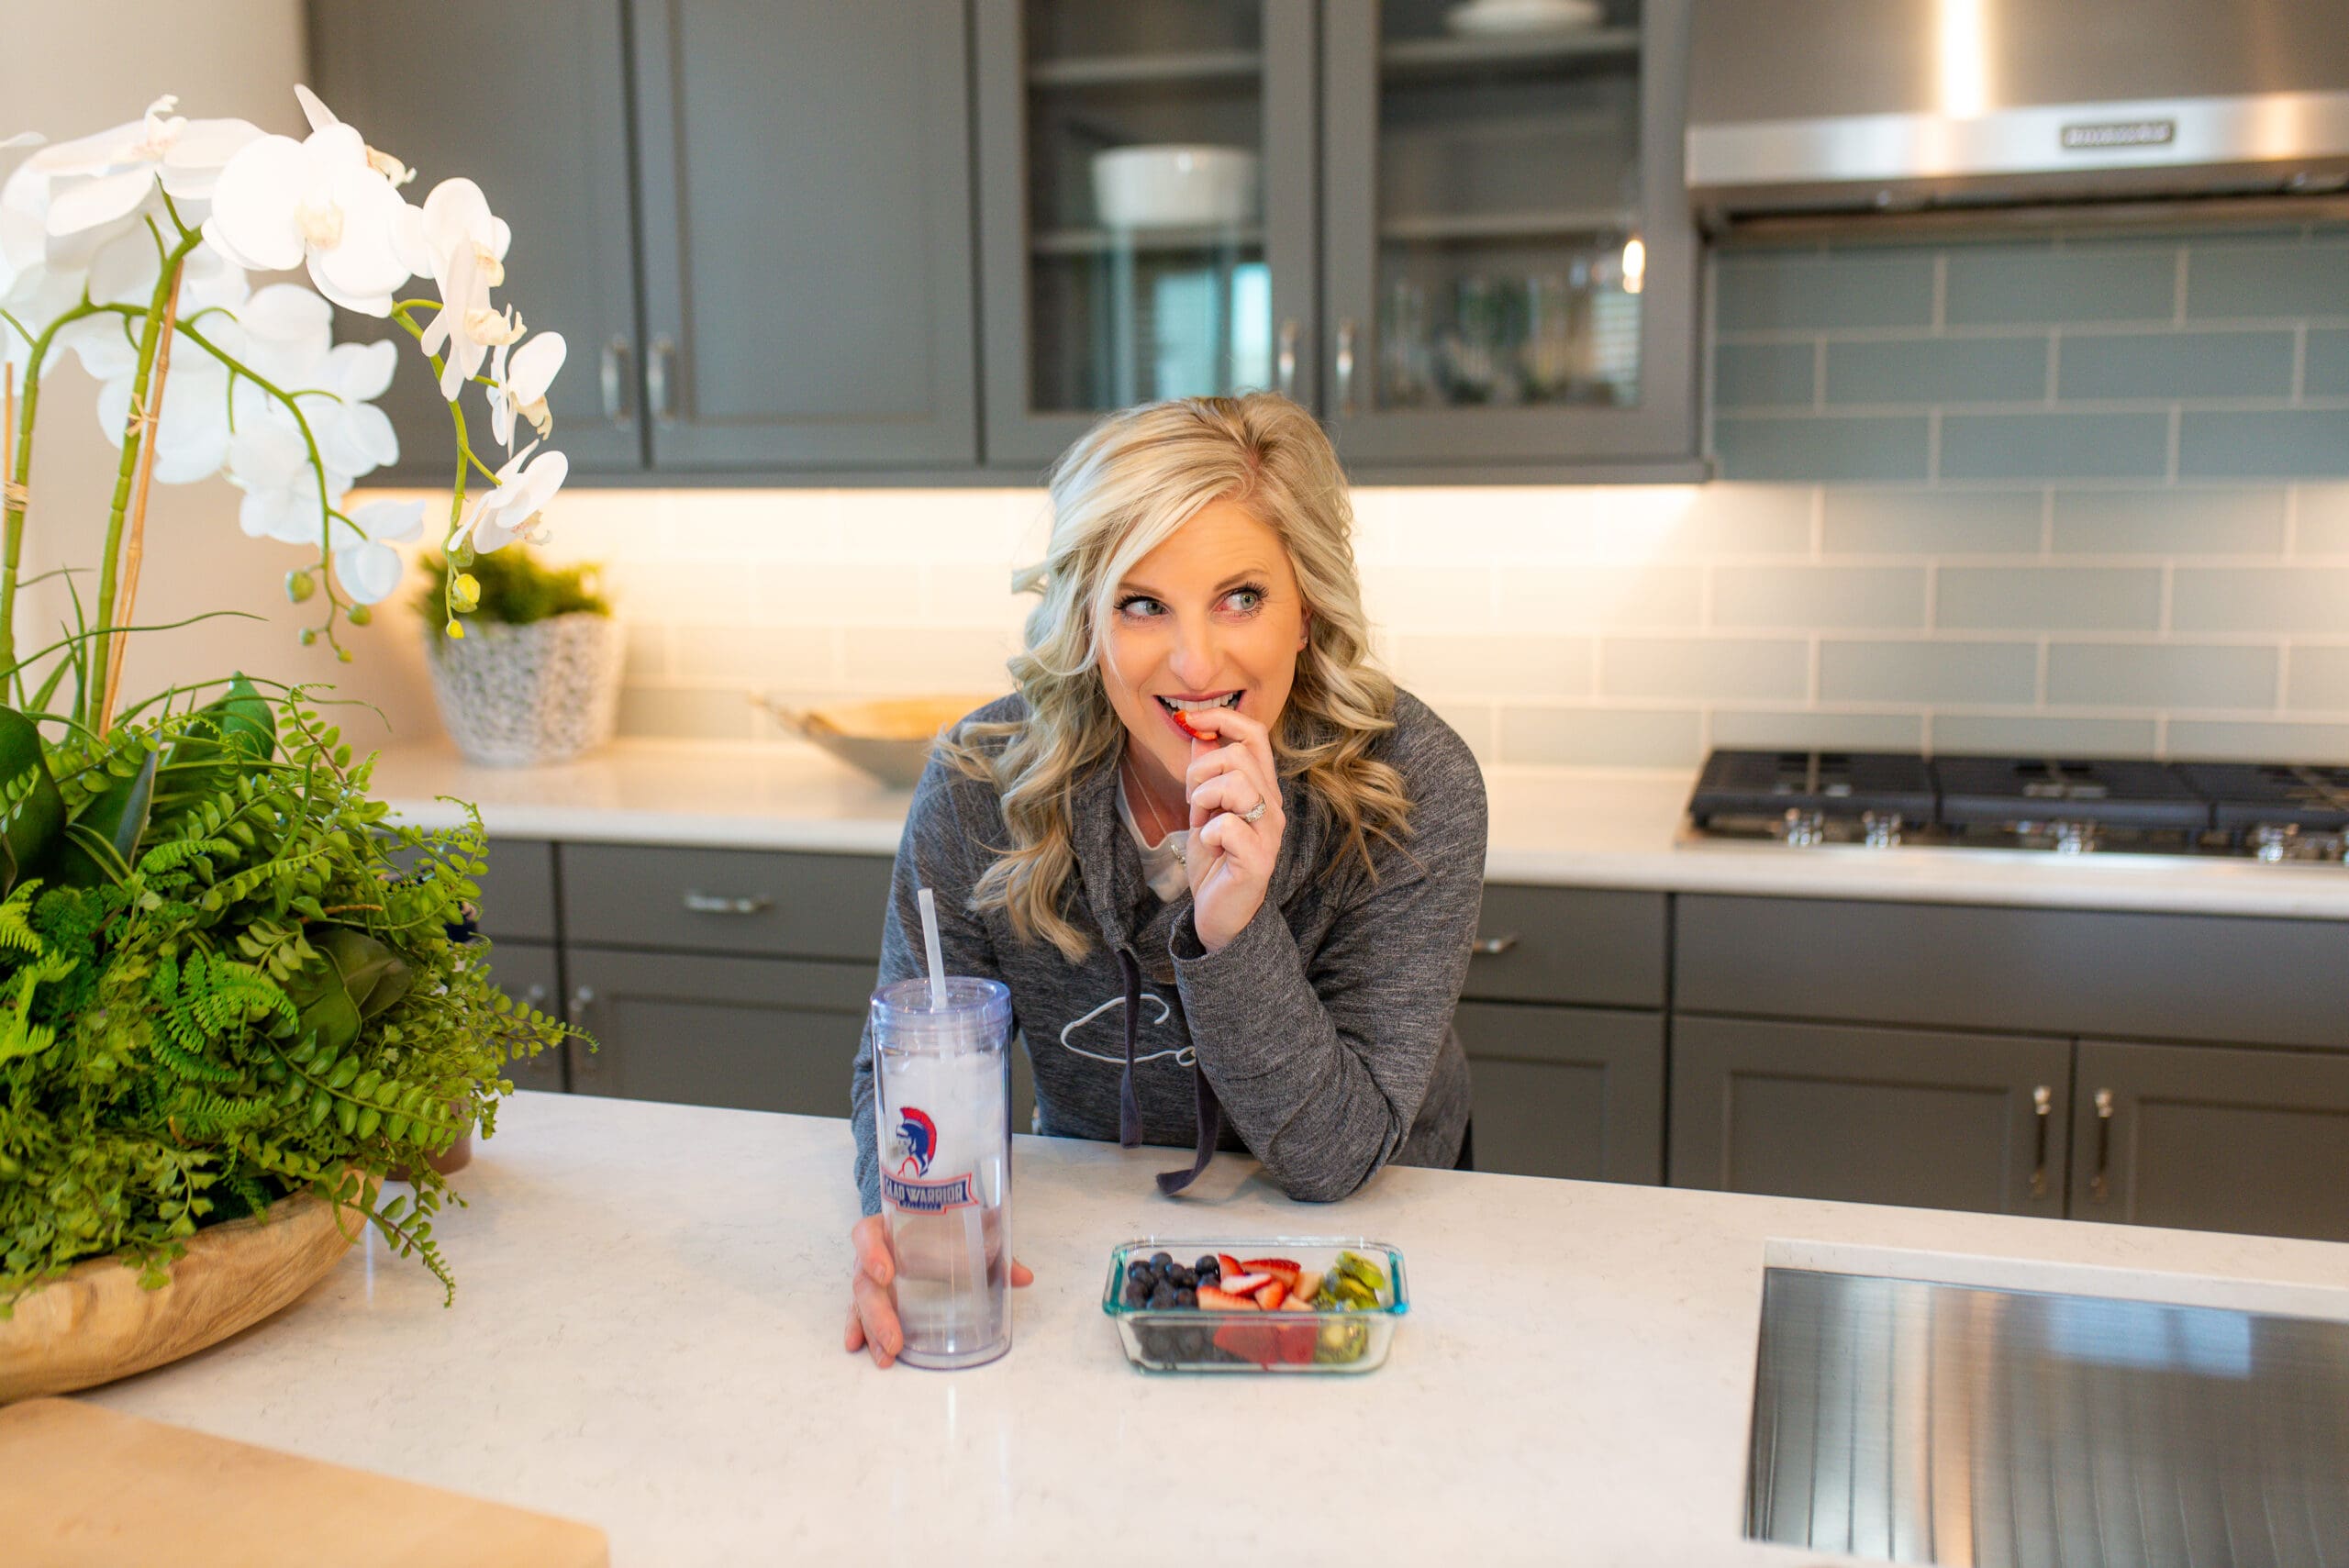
[0,678,573,1315]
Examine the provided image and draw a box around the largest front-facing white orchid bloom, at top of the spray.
[205,96,418,317]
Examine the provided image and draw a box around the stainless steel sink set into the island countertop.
[1745,1268,2349,1568]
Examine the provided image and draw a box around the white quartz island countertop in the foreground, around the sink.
[92,1094,2349,1568]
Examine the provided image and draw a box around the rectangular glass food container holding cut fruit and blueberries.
[1102,1237,1412,1375]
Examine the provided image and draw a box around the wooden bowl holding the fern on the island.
[0,1193,366,1404]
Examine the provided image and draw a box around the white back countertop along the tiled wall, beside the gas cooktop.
[362,741,2349,920]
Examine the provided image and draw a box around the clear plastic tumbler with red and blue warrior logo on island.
[872,976,1012,1369]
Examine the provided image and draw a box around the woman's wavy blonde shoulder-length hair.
[940,392,1412,962]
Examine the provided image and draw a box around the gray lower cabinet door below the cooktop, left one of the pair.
[1670,1014,2072,1216]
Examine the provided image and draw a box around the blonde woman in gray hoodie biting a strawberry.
[846,395,1485,1366]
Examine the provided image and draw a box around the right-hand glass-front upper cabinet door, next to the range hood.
[1322,0,1696,470]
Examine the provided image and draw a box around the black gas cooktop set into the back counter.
[1689,751,2349,863]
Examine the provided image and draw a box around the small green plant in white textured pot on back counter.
[420,545,620,768]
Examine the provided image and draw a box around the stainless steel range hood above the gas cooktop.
[1687,0,2349,228]
